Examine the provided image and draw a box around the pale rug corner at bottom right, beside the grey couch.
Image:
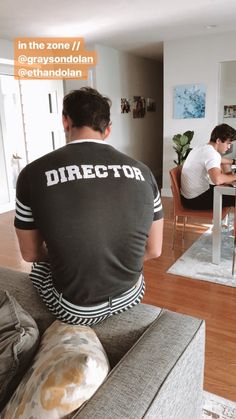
[201,391,236,419]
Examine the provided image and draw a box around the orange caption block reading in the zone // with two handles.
[14,38,97,80]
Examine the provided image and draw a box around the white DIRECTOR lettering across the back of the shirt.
[45,164,145,186]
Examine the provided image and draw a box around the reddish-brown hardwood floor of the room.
[0,198,236,401]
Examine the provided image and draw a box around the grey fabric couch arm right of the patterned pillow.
[73,310,205,419]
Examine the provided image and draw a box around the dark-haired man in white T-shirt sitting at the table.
[181,124,236,210]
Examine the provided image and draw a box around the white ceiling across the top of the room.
[0,0,236,61]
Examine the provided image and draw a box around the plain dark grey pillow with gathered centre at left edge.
[0,290,39,410]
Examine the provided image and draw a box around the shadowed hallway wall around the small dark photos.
[94,45,163,176]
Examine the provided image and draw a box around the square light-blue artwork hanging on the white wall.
[173,84,206,119]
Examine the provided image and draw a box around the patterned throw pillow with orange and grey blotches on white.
[2,320,110,419]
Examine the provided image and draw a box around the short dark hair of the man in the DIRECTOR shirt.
[62,87,111,133]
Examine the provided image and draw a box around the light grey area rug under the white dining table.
[167,229,236,287]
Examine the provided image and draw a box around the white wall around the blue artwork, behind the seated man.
[162,32,236,196]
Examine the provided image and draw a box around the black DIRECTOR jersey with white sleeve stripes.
[14,140,163,305]
